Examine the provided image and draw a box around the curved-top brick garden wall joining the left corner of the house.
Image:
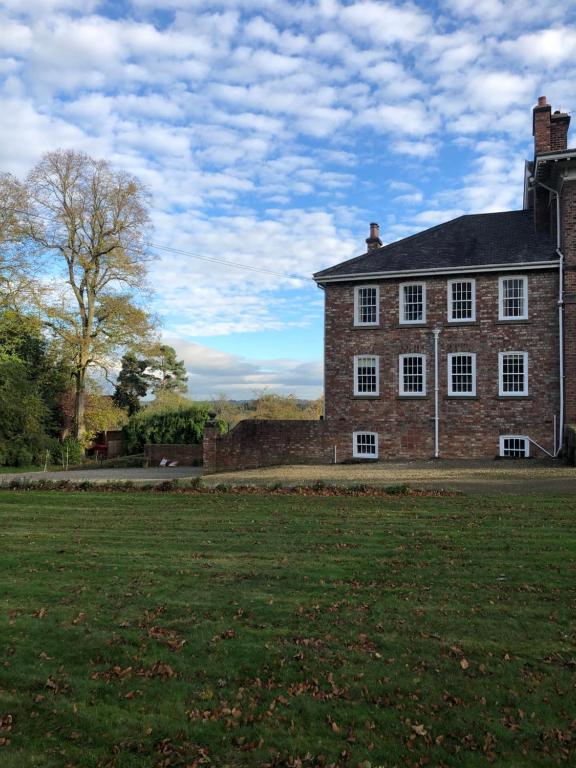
[204,419,345,473]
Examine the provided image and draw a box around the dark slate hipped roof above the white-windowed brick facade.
[314,211,558,283]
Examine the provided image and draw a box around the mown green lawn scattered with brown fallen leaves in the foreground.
[0,491,576,768]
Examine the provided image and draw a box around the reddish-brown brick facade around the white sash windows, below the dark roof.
[325,269,560,460]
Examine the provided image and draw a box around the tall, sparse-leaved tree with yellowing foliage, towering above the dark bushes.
[24,150,151,438]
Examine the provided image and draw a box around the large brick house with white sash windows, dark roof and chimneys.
[314,97,576,460]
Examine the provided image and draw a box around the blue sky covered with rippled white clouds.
[0,0,576,398]
